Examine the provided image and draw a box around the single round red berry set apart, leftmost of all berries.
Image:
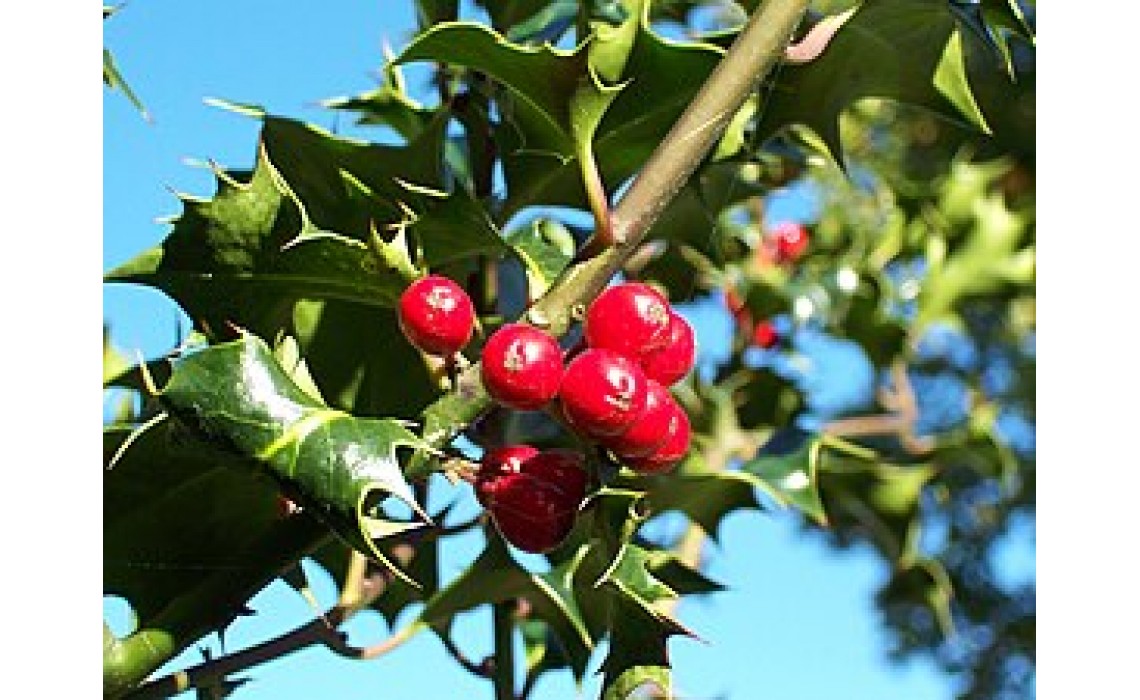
[397,275,475,357]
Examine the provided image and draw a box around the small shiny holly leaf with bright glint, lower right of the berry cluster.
[740,430,828,524]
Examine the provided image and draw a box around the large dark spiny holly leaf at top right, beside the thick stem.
[757,0,1007,163]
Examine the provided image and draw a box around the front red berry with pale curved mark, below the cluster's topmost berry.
[559,348,648,438]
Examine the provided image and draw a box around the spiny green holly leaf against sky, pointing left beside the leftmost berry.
[105,144,417,335]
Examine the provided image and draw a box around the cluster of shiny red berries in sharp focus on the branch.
[397,275,695,552]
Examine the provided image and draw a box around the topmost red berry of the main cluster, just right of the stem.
[585,282,669,359]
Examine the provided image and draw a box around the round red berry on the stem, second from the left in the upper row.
[480,324,562,410]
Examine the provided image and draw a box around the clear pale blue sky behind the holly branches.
[103,0,1034,700]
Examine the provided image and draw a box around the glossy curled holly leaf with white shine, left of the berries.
[158,332,428,578]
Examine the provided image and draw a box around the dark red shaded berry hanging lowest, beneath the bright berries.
[477,445,587,553]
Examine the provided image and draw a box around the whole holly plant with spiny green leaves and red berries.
[104,0,1036,700]
